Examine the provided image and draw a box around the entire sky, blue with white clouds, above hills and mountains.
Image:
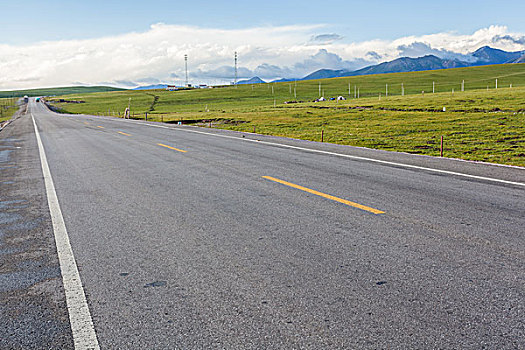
[0,0,525,90]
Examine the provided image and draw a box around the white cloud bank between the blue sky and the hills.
[0,24,525,90]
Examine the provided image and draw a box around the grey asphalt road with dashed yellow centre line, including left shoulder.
[0,101,525,349]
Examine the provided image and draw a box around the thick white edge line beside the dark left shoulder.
[31,113,100,350]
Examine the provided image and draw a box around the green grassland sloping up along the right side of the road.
[48,64,525,166]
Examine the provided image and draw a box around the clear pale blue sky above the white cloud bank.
[4,0,525,44]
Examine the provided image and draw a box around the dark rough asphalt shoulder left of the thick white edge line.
[0,115,73,349]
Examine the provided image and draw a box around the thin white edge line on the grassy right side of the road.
[115,120,525,187]
